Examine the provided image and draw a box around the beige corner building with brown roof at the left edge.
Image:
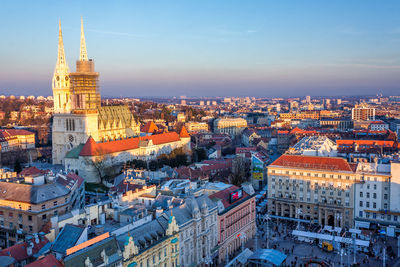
[0,173,84,247]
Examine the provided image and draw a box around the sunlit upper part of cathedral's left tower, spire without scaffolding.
[52,21,71,113]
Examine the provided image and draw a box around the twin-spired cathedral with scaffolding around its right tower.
[52,20,140,164]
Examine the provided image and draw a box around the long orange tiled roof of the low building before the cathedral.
[79,132,180,156]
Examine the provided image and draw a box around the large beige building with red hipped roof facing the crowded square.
[268,155,360,227]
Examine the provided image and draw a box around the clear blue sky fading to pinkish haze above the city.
[0,0,400,97]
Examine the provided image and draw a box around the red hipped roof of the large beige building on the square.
[269,155,353,172]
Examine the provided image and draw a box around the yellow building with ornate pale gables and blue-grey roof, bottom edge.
[117,213,179,267]
